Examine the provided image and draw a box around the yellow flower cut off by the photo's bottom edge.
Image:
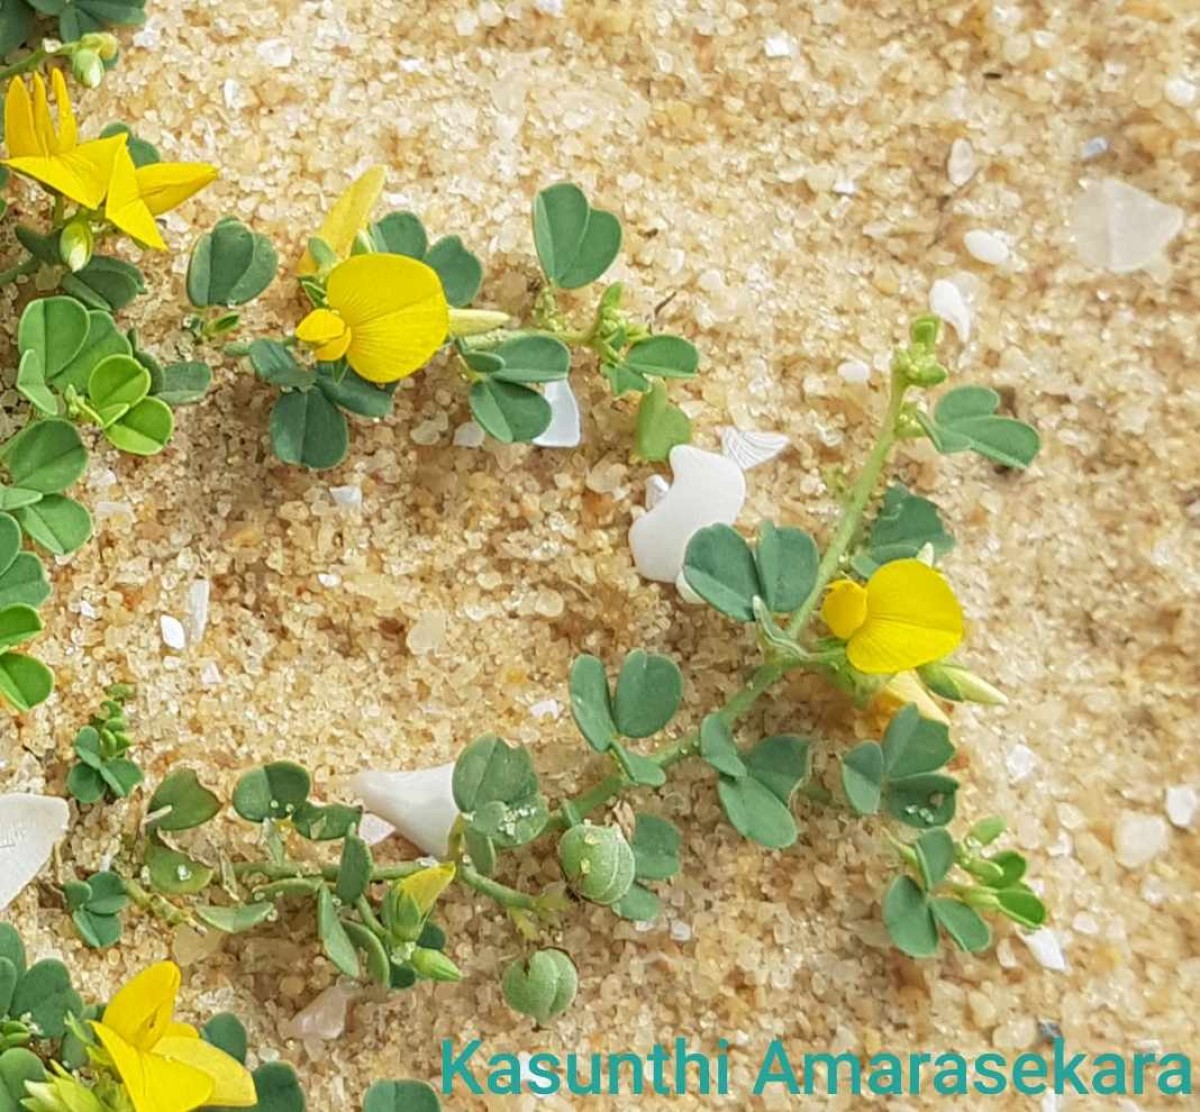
[91,961,258,1112]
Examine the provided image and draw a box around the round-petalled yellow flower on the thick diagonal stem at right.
[821,560,962,675]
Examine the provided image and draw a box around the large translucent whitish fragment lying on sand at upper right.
[1070,178,1183,274]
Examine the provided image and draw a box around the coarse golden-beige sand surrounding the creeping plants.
[0,0,1200,1112]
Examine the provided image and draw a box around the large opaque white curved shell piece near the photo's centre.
[629,444,746,583]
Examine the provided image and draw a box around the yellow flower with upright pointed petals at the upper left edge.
[4,70,126,209]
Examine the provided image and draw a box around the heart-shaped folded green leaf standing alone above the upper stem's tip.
[533,181,622,289]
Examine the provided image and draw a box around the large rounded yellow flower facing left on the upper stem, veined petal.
[296,254,450,383]
